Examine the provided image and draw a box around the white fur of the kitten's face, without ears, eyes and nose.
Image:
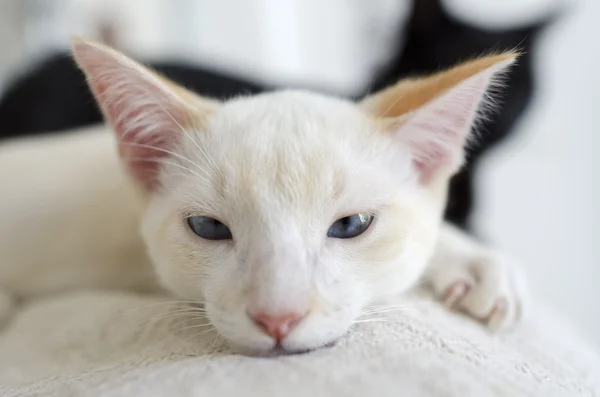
[136,92,437,350]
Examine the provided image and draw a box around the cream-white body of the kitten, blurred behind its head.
[0,127,153,298]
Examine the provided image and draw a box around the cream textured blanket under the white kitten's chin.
[0,292,600,397]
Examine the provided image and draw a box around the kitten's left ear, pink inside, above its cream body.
[72,38,217,190]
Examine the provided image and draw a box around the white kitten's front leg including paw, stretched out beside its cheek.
[425,224,527,330]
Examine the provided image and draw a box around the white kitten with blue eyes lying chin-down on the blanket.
[0,40,523,352]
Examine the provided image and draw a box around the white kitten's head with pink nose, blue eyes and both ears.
[74,40,515,352]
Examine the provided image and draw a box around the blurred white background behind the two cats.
[0,0,600,346]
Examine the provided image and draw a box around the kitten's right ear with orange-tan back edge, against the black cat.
[361,53,517,184]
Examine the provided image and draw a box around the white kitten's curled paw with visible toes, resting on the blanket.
[429,252,528,330]
